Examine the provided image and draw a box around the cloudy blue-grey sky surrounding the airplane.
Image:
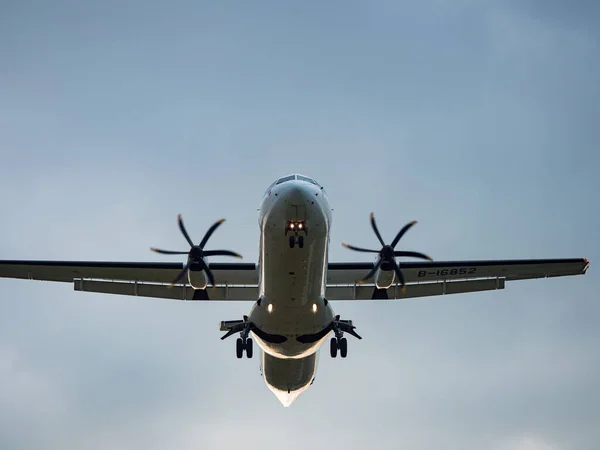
[0,0,600,450]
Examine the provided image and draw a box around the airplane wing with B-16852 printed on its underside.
[325,258,589,300]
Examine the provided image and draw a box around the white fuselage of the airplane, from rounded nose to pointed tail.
[249,175,334,406]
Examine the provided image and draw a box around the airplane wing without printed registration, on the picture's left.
[0,260,258,301]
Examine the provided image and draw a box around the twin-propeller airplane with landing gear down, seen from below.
[0,174,589,407]
